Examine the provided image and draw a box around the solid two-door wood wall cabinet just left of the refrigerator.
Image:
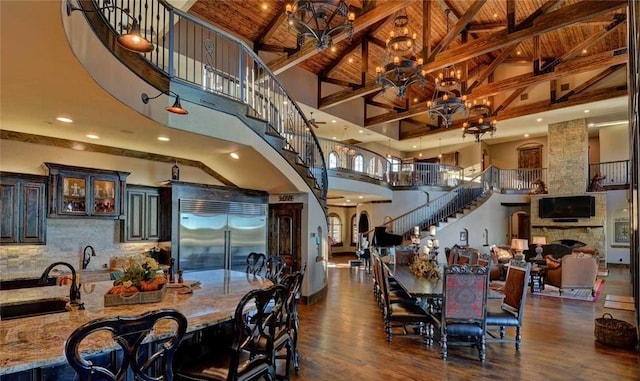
[121,185,160,242]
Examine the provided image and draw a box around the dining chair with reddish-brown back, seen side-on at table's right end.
[487,260,531,350]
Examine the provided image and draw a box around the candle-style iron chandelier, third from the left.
[427,9,467,128]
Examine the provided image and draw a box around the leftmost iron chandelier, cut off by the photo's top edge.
[285,0,356,50]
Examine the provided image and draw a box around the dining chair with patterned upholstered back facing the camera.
[440,265,489,362]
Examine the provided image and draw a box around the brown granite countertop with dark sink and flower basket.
[0,270,272,375]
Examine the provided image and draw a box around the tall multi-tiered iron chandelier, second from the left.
[376,12,426,98]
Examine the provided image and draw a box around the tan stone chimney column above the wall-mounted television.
[547,119,589,195]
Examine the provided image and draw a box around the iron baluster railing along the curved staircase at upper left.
[79,0,328,205]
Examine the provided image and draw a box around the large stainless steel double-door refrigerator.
[178,199,268,272]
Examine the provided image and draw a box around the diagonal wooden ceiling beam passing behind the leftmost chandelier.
[269,0,413,75]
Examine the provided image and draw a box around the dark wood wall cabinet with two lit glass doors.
[45,163,129,218]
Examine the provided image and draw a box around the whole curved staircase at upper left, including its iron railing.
[79,0,328,214]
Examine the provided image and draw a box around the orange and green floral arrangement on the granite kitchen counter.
[109,254,166,294]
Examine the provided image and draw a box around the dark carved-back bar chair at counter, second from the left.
[176,285,287,381]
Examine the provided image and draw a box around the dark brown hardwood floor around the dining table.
[292,256,640,381]
